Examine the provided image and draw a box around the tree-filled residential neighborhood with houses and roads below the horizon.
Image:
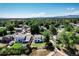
[0,18,79,56]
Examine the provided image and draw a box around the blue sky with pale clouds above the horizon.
[0,3,79,18]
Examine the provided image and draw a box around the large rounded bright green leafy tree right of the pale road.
[58,31,77,47]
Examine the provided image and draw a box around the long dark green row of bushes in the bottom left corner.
[0,44,32,56]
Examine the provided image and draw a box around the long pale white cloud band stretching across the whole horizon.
[0,10,79,18]
